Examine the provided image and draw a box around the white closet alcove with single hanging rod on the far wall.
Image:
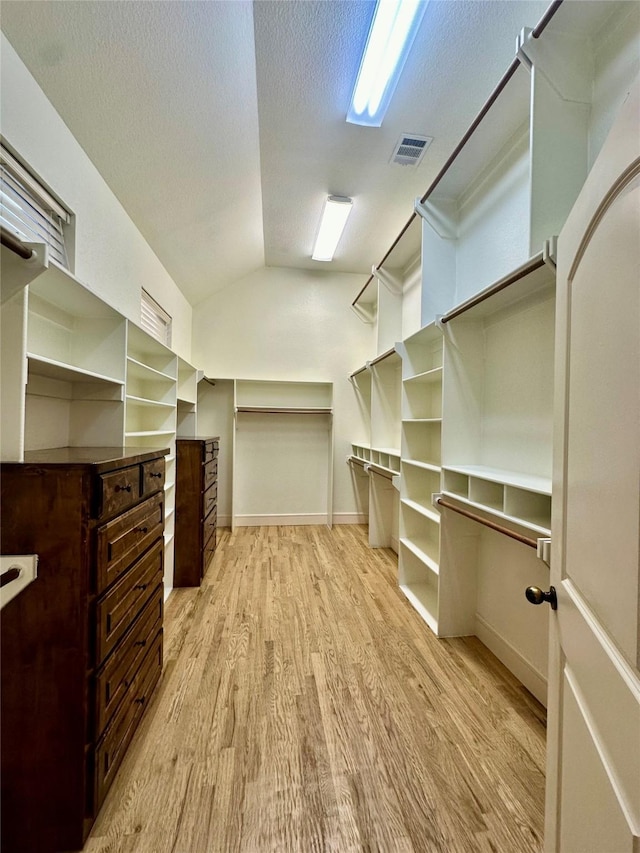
[231,379,333,527]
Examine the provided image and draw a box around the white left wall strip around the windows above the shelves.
[0,35,192,361]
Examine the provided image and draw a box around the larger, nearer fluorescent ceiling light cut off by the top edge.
[347,0,427,127]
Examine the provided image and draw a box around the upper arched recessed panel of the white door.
[565,180,640,665]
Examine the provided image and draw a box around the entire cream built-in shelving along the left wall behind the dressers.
[0,259,202,590]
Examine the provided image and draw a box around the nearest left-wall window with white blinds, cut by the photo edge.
[0,145,71,269]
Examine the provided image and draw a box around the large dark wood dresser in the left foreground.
[0,448,169,853]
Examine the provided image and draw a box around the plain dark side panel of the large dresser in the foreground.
[0,465,90,853]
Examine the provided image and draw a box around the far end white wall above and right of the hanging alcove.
[193,268,373,522]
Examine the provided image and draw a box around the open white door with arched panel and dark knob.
[545,78,640,853]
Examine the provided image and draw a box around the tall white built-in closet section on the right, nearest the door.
[354,3,638,701]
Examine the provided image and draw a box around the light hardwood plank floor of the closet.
[85,526,545,853]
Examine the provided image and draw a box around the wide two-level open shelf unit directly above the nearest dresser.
[21,261,126,459]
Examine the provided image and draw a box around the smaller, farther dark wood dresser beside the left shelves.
[173,436,220,586]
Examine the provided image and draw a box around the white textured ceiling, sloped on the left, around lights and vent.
[2,0,568,304]
